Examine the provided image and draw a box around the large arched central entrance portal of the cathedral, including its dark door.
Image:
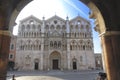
[49,51,61,70]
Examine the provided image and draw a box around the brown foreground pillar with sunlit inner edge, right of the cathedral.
[101,31,120,80]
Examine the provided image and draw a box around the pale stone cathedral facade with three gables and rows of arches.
[15,15,95,70]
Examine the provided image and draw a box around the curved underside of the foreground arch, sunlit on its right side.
[8,0,108,73]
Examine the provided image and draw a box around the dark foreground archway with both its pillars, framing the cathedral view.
[0,0,120,80]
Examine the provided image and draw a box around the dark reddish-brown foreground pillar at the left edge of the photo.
[0,30,10,80]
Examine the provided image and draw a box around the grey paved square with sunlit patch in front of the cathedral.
[7,70,100,80]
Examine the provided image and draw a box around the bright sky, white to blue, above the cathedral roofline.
[13,0,101,53]
